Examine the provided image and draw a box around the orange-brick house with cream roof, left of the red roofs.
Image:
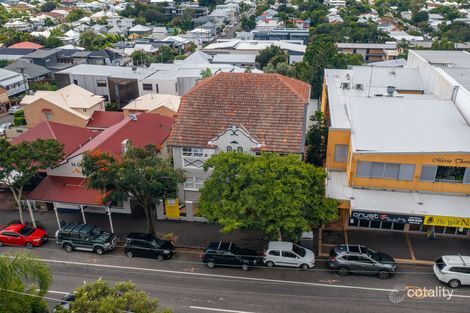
[21,84,104,127]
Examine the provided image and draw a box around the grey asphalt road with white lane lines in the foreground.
[0,242,470,313]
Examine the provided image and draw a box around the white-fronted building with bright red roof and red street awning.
[28,113,174,222]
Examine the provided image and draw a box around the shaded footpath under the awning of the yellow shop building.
[320,230,470,265]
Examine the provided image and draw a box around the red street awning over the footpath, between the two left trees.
[27,176,102,205]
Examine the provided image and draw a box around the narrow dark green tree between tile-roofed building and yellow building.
[306,111,328,167]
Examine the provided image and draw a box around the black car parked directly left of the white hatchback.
[201,241,258,271]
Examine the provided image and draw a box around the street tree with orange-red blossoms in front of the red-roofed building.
[82,145,186,234]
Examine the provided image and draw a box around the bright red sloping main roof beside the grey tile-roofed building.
[73,113,174,156]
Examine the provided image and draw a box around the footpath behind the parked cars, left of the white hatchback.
[0,209,266,251]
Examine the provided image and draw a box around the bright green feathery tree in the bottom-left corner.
[0,254,52,313]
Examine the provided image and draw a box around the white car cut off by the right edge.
[433,254,470,288]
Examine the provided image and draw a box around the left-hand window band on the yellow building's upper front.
[356,161,416,180]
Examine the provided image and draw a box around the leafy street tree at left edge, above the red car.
[0,139,64,222]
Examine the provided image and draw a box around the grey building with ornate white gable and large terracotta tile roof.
[168,73,310,202]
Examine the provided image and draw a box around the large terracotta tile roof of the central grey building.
[169,73,310,153]
